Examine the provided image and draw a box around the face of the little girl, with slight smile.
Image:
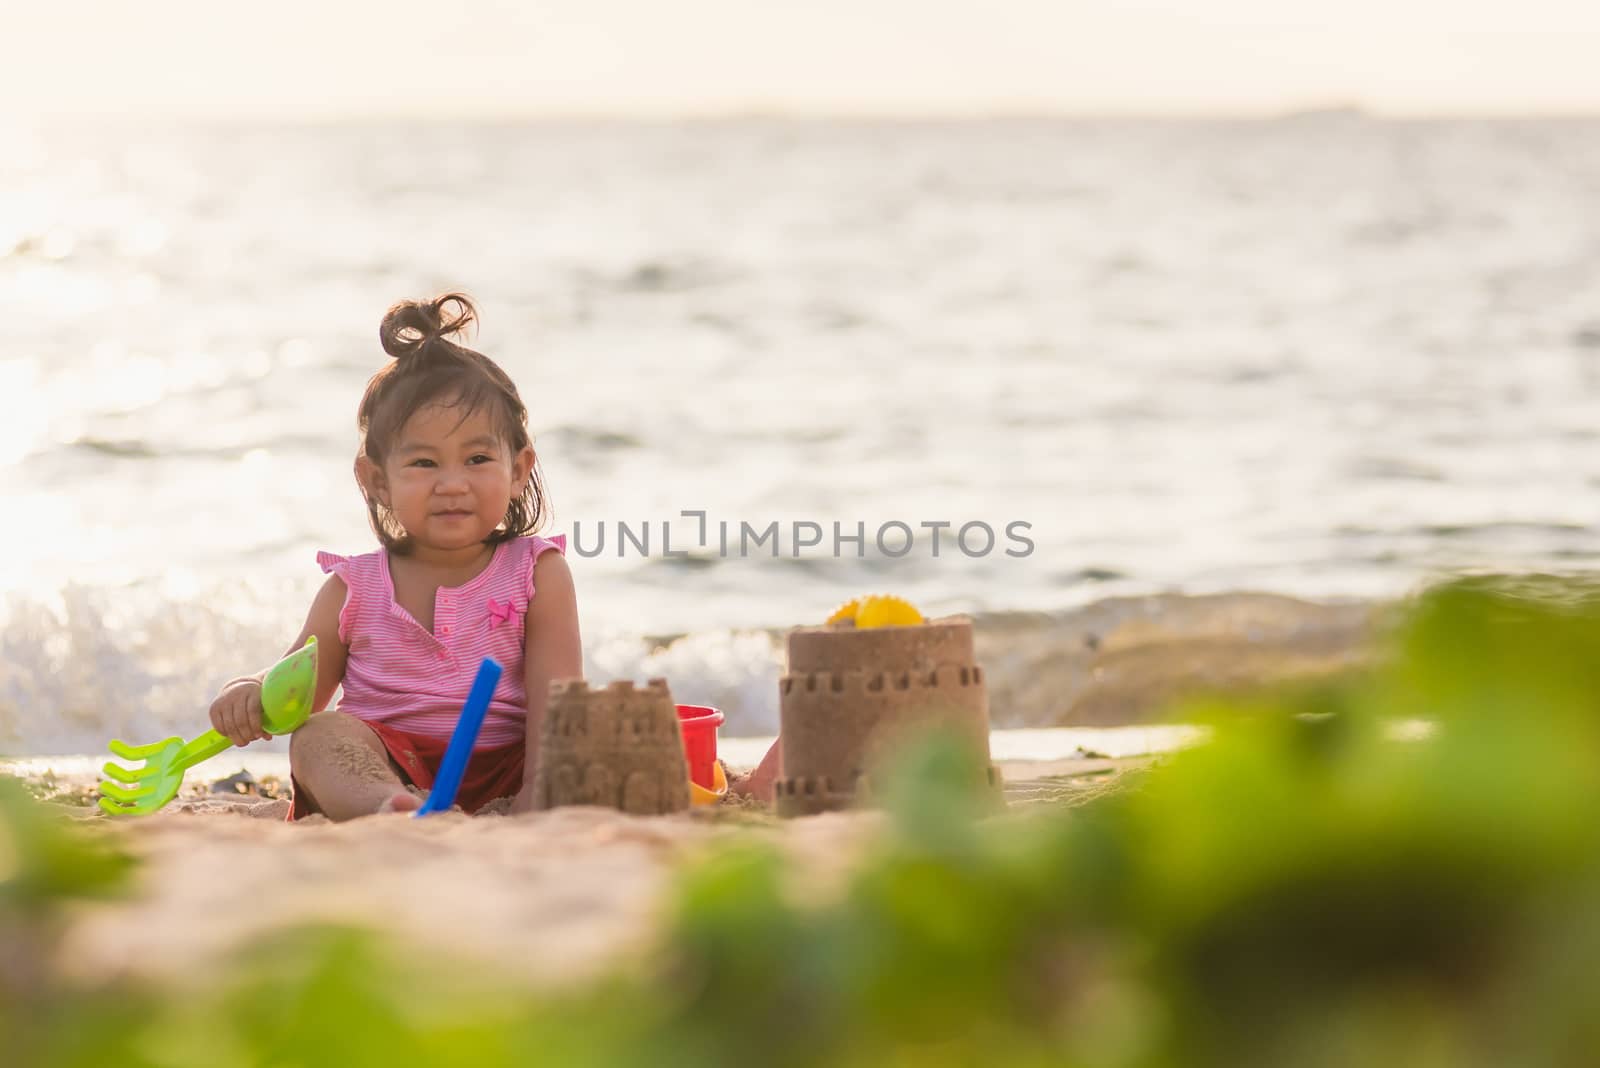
[357,401,533,552]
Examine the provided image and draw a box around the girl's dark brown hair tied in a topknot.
[357,293,549,553]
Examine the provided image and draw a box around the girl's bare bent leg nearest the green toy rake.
[290,711,422,820]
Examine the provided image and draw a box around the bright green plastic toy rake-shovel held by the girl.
[99,636,317,815]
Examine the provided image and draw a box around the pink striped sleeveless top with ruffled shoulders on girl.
[317,534,566,750]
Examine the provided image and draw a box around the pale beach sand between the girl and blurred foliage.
[28,758,1149,983]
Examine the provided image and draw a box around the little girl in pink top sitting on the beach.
[211,293,582,820]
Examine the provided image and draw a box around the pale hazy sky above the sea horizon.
[9,0,1600,120]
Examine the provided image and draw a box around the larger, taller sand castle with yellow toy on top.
[776,598,1000,817]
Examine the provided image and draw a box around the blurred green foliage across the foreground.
[9,579,1600,1068]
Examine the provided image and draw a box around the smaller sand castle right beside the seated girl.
[533,678,690,815]
